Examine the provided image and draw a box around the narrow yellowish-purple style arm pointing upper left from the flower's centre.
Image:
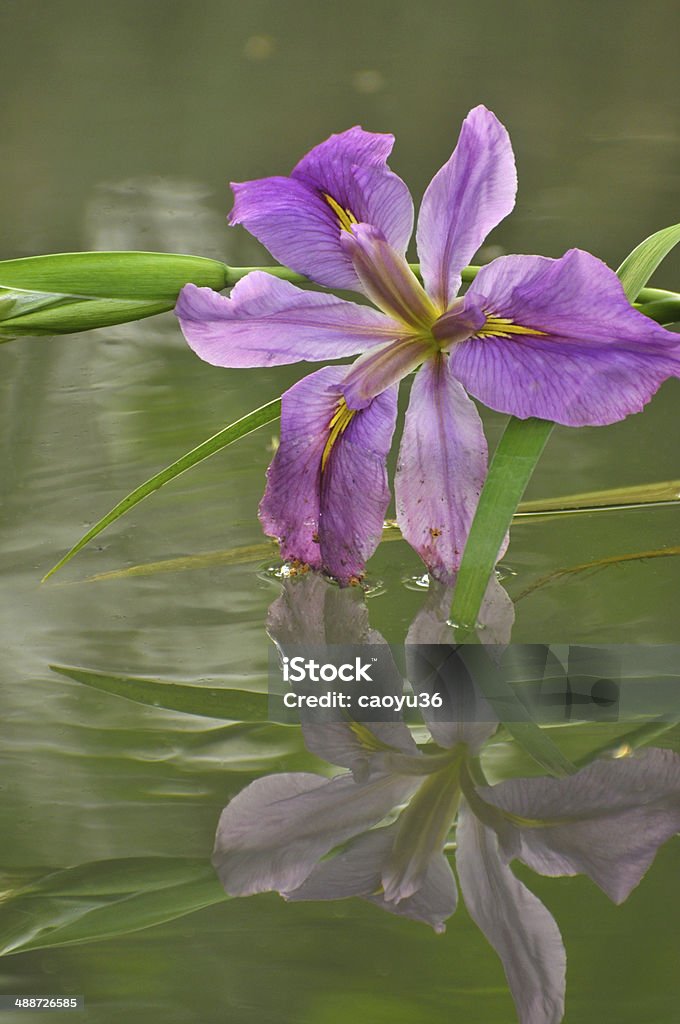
[341,224,438,333]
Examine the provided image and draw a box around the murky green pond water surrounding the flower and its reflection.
[0,0,680,1024]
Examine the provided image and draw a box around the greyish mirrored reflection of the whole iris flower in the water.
[213,574,680,1024]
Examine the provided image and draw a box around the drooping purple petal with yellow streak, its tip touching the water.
[260,367,396,583]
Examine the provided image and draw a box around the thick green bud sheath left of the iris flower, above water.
[0,252,230,337]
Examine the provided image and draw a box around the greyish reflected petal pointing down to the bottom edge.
[456,806,566,1024]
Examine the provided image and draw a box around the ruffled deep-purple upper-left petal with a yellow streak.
[229,127,413,289]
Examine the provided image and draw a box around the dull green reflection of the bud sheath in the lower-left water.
[0,857,228,955]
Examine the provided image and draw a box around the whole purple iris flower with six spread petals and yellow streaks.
[176,106,680,584]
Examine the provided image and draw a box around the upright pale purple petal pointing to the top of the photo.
[417,106,517,312]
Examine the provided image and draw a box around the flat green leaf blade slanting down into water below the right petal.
[451,417,554,633]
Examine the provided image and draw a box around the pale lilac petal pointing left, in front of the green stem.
[175,271,396,367]
